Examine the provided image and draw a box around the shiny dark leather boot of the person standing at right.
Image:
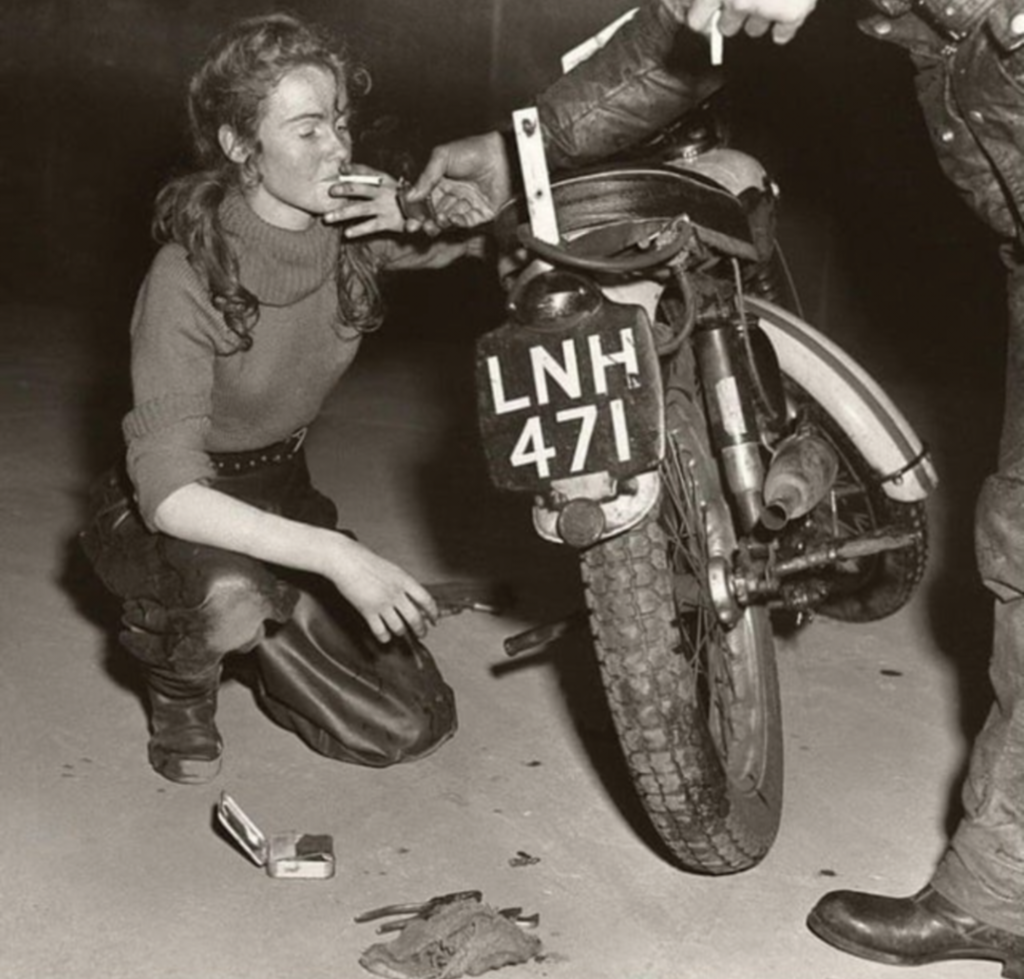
[807,886,1024,979]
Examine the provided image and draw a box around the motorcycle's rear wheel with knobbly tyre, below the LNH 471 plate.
[582,389,782,875]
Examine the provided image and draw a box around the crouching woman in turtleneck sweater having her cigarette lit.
[82,15,479,782]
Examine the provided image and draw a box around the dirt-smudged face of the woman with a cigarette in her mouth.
[234,66,352,230]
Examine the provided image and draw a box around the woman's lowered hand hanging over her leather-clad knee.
[323,534,437,643]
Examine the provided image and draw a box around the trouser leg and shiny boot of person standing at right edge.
[808,268,1024,979]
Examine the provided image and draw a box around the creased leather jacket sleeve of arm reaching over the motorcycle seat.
[537,0,722,170]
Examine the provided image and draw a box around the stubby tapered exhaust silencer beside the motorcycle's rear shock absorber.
[761,430,839,531]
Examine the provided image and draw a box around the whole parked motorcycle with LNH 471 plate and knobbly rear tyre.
[476,104,937,875]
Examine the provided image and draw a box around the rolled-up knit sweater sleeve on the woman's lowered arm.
[123,245,217,529]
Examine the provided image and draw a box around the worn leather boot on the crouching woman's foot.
[146,667,223,785]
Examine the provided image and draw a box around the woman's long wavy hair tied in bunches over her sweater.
[153,14,383,350]
